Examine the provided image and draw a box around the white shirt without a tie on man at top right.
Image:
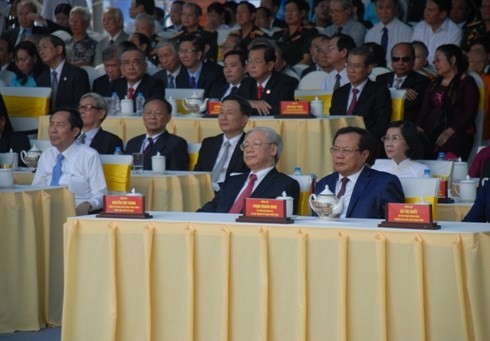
[412,18,463,64]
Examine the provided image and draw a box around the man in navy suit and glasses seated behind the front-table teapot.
[316,127,405,219]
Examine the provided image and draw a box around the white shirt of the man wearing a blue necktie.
[32,142,107,209]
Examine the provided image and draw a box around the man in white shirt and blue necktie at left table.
[32,108,107,215]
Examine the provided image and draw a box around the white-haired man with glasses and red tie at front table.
[198,127,299,213]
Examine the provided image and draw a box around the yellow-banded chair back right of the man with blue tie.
[100,154,133,193]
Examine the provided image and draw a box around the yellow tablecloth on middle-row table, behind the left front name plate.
[14,171,214,212]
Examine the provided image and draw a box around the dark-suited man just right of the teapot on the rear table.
[209,50,247,100]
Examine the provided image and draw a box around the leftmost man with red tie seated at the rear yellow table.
[112,49,165,111]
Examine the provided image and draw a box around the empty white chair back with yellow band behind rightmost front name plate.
[400,178,440,220]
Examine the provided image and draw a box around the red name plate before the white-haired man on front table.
[236,198,294,224]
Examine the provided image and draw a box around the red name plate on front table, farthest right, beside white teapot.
[378,203,441,230]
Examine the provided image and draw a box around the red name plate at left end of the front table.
[97,195,151,219]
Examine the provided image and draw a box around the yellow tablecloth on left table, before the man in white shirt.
[0,186,75,334]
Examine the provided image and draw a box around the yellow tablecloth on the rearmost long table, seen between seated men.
[38,116,364,177]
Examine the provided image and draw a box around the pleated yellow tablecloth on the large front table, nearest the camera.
[62,212,490,341]
